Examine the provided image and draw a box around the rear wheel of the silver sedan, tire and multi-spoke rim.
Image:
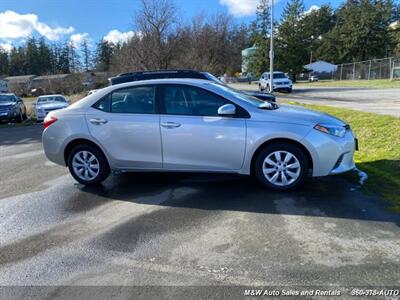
[68,145,110,185]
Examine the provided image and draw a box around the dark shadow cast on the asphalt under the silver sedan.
[75,173,400,225]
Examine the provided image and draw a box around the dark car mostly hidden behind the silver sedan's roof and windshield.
[108,70,276,102]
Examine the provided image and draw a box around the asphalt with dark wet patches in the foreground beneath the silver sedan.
[0,125,400,296]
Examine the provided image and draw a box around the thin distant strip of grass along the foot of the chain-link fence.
[295,79,400,88]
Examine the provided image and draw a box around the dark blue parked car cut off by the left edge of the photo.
[0,93,27,123]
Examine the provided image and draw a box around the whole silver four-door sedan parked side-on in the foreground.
[43,79,356,190]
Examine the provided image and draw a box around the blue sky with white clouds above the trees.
[0,0,340,48]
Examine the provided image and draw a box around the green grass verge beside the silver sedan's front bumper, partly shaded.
[291,102,400,213]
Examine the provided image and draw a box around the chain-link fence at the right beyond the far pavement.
[333,57,400,80]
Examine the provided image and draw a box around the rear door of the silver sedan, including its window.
[86,85,162,169]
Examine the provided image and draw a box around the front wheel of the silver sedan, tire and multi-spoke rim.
[254,143,308,191]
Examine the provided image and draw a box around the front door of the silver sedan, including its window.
[160,84,246,171]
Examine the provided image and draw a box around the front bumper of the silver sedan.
[303,129,357,176]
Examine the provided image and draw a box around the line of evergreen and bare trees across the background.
[0,0,400,79]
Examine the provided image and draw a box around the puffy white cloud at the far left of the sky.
[0,10,74,41]
